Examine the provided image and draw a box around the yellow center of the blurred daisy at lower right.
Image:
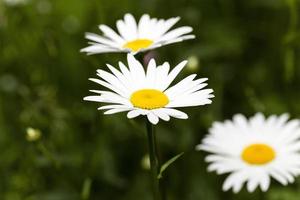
[241,144,276,165]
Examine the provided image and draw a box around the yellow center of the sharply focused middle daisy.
[130,89,169,110]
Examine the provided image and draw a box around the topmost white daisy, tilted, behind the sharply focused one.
[81,14,195,54]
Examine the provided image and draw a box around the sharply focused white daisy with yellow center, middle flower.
[84,54,213,124]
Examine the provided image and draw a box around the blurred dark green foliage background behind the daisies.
[0,0,300,200]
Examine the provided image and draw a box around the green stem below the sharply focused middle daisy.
[146,119,164,200]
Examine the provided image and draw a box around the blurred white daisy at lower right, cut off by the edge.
[196,113,300,193]
